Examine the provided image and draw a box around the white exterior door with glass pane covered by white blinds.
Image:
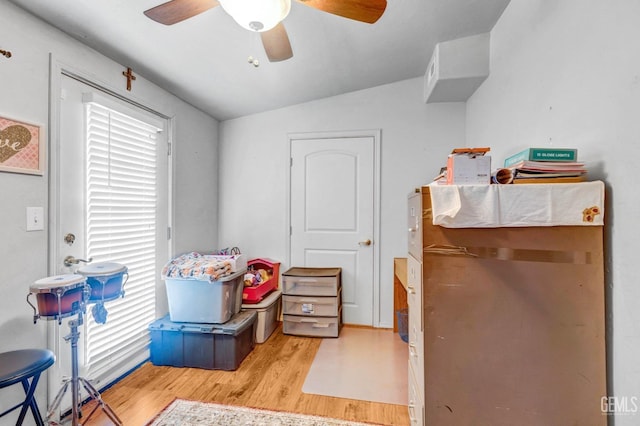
[49,76,169,410]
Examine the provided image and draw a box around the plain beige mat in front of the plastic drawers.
[302,327,409,405]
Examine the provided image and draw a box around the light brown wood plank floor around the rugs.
[83,325,409,426]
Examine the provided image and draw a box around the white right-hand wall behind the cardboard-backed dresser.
[467,0,640,420]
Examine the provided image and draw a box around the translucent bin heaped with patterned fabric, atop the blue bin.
[161,252,246,324]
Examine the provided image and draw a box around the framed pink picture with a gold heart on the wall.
[0,116,45,175]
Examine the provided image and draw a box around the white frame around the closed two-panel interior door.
[285,129,382,328]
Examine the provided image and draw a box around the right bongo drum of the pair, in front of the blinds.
[78,262,129,303]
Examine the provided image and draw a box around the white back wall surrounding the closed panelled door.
[219,78,465,327]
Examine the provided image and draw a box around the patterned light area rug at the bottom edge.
[147,399,378,426]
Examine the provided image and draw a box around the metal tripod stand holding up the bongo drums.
[47,310,122,426]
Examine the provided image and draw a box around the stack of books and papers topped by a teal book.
[504,148,587,183]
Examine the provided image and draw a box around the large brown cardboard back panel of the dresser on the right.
[423,188,607,425]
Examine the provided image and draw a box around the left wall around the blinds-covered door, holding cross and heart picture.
[0,2,218,424]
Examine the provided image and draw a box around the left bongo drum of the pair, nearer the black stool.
[27,274,86,322]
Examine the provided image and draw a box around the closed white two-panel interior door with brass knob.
[290,136,377,326]
